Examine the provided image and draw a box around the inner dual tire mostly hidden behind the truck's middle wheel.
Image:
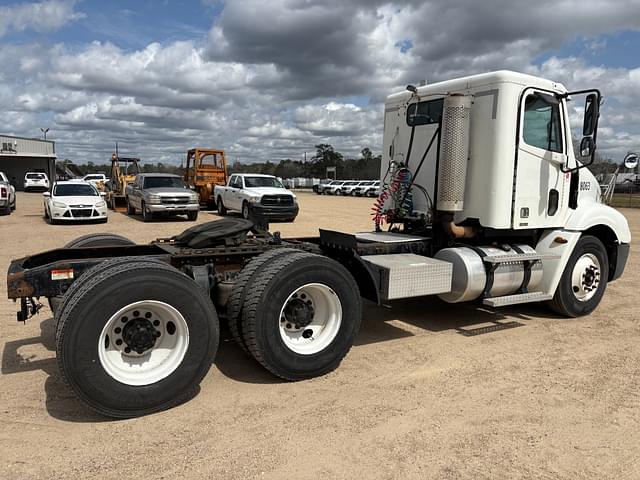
[226,248,304,355]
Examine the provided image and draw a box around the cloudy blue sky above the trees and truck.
[0,0,640,162]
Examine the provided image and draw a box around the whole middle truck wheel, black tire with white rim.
[242,254,362,380]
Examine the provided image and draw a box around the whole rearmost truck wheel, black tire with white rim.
[56,259,219,418]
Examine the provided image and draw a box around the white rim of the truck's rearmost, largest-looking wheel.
[98,300,189,386]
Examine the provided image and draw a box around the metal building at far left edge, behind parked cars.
[0,135,56,190]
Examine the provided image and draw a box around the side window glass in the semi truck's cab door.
[522,93,562,152]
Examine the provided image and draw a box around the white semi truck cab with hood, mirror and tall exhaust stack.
[376,71,631,314]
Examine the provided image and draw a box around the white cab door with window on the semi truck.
[512,88,571,229]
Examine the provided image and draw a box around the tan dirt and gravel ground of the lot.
[0,193,640,479]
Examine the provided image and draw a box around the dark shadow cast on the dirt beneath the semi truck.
[0,297,557,423]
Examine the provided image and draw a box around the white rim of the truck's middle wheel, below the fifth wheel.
[278,283,342,355]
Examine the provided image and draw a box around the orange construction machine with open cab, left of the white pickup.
[184,147,227,208]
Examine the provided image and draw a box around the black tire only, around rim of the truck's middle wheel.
[242,254,362,380]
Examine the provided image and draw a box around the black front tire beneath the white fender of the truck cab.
[549,235,609,317]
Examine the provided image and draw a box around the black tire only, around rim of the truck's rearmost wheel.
[56,259,219,418]
